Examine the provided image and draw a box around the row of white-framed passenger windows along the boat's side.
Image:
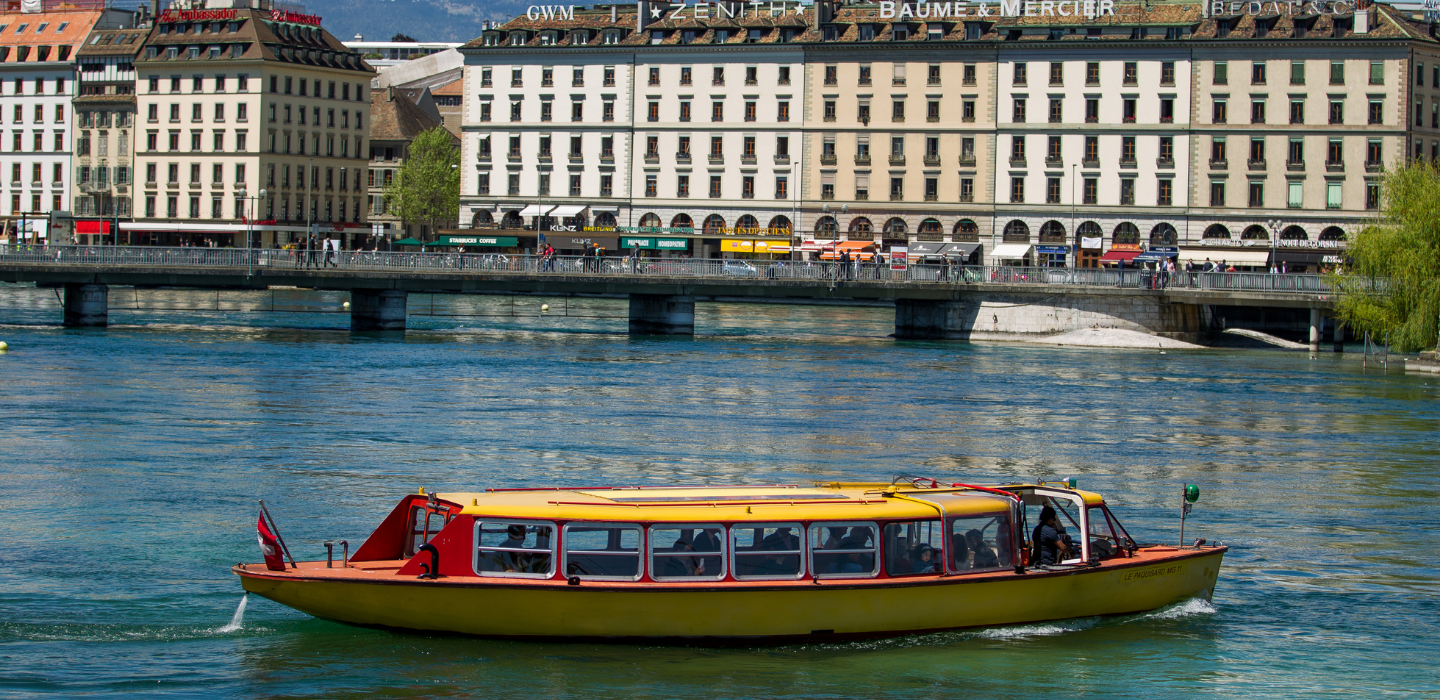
[475,511,1015,582]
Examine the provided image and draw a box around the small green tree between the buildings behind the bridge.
[384,127,459,241]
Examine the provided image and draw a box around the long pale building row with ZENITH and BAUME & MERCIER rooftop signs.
[461,1,1440,271]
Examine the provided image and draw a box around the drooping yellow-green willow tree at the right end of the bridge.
[1329,161,1440,353]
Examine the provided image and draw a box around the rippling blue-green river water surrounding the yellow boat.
[0,287,1440,699]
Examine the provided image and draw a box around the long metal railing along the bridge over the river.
[0,245,1332,294]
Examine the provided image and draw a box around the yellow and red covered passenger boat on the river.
[233,477,1227,644]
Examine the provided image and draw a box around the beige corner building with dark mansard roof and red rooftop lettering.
[124,1,374,248]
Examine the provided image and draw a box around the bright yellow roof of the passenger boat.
[435,483,1102,523]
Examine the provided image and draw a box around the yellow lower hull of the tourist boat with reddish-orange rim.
[235,547,1225,642]
